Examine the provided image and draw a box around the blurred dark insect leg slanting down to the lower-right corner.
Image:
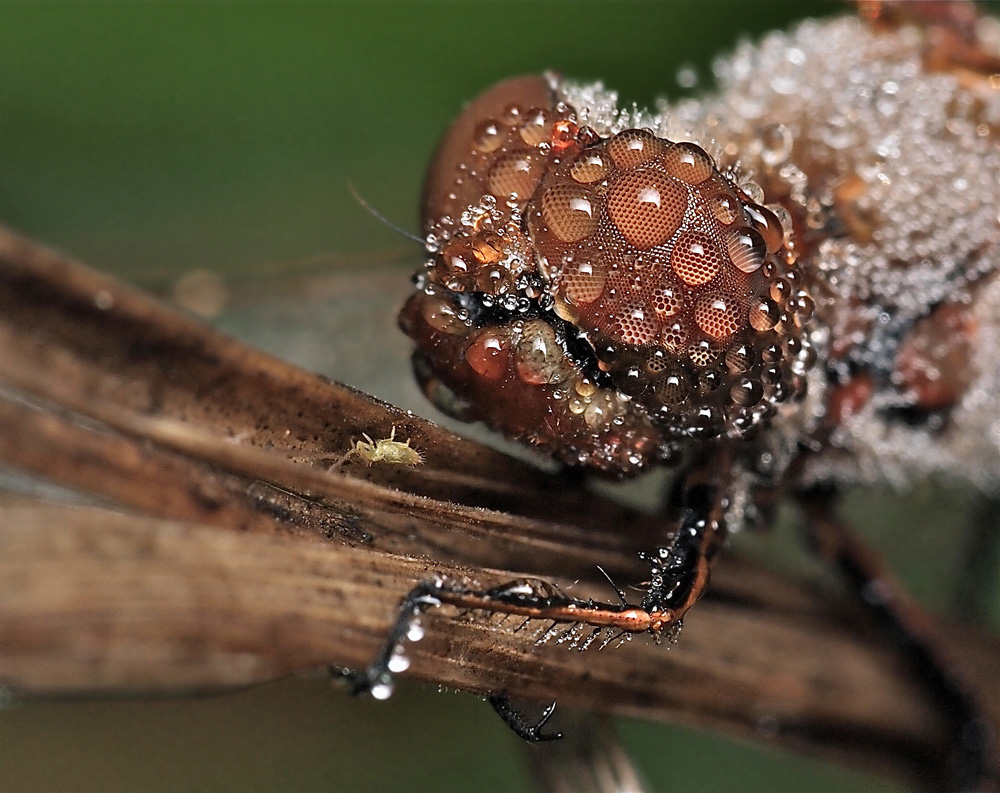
[800,488,993,793]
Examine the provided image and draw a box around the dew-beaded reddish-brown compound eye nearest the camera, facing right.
[527,130,812,437]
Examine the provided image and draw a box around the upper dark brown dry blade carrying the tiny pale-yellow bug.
[0,227,624,525]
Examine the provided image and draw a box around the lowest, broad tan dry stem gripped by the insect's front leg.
[0,505,976,776]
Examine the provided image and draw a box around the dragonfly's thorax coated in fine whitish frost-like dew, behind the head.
[561,18,1000,488]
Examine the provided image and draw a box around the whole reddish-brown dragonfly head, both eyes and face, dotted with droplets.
[403,77,812,473]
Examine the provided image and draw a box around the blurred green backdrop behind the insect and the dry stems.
[0,2,996,793]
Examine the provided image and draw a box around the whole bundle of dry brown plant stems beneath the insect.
[0,226,1000,788]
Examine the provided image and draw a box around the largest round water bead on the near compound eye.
[608,171,688,250]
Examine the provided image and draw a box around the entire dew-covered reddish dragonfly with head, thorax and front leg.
[356,3,1000,784]
